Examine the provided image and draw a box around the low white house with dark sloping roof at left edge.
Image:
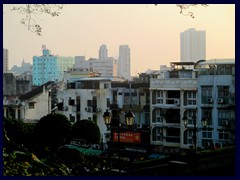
[3,82,53,123]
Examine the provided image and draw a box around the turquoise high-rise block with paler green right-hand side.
[32,48,74,86]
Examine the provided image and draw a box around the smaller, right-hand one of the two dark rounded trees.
[71,120,100,144]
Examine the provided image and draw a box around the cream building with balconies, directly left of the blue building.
[150,62,197,152]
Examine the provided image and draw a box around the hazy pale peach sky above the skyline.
[3,4,235,75]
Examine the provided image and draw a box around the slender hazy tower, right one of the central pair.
[118,45,131,79]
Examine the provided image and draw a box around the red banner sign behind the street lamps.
[113,132,141,143]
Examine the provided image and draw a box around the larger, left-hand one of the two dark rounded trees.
[35,113,71,148]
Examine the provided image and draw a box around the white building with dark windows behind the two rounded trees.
[57,77,112,142]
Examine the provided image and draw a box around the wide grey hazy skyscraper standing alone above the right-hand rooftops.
[180,28,206,62]
